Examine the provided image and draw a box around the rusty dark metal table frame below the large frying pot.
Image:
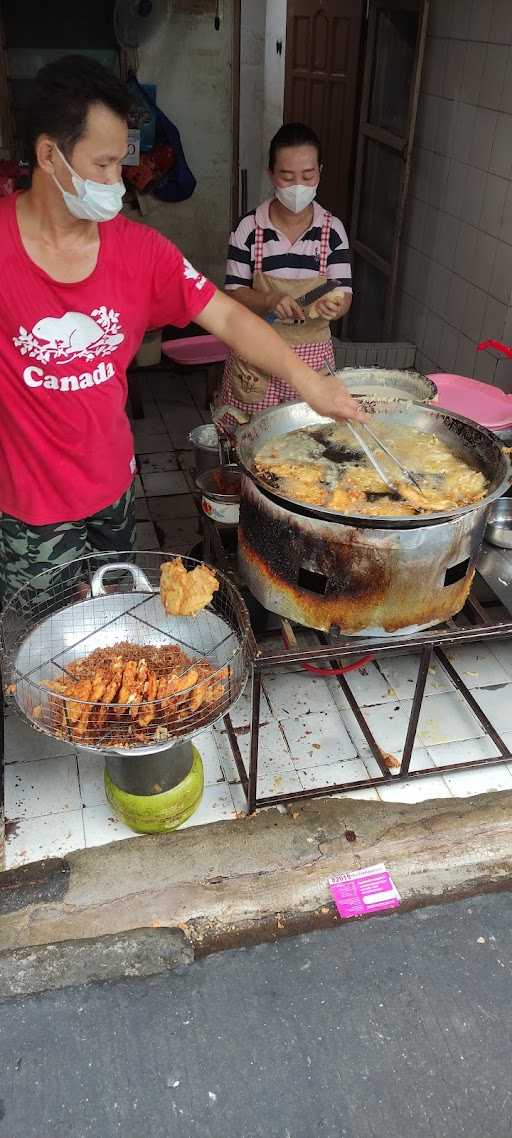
[220,582,512,814]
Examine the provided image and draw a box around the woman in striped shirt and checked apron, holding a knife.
[217,123,352,434]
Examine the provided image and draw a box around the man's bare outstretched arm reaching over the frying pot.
[196,292,363,420]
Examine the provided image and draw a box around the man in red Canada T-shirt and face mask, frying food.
[0,56,358,600]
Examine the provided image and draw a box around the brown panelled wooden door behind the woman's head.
[284,0,363,218]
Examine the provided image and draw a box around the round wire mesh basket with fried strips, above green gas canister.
[0,552,254,753]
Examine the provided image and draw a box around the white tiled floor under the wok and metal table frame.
[6,376,512,866]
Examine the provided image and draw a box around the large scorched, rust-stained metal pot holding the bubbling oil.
[238,401,512,636]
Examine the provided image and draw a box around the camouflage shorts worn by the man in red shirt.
[0,485,135,604]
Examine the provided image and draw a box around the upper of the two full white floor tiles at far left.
[6,754,81,818]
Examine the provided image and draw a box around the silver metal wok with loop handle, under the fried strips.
[1,553,253,756]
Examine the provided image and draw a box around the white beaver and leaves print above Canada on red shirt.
[13,305,124,364]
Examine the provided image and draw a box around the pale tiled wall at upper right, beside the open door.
[396,0,512,390]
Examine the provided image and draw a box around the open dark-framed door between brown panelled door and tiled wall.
[345,0,429,340]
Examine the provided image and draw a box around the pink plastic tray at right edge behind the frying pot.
[429,372,512,430]
